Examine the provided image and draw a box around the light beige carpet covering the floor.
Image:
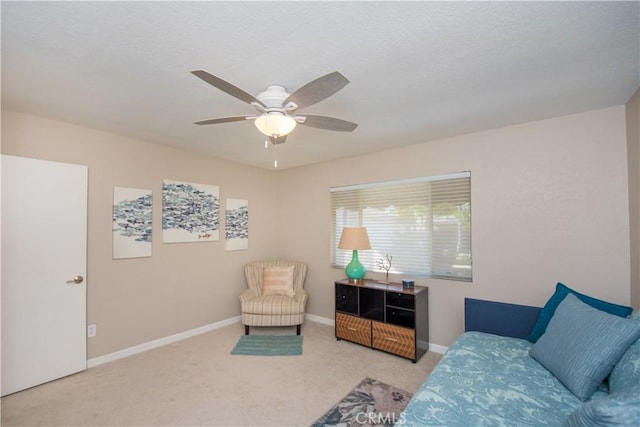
[2,321,441,427]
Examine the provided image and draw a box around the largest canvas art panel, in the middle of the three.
[162,180,220,243]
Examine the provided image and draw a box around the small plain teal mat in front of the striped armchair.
[231,335,302,356]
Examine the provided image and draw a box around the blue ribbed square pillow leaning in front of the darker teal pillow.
[529,294,640,400]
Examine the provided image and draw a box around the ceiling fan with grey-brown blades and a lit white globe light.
[191,70,358,144]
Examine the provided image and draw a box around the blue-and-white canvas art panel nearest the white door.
[112,187,153,259]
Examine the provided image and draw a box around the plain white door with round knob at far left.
[1,155,88,396]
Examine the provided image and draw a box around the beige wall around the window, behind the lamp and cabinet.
[278,106,630,346]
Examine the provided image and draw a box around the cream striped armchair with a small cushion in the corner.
[240,261,308,335]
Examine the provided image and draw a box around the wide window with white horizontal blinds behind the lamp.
[331,172,472,281]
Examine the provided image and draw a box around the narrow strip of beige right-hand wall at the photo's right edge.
[626,89,640,307]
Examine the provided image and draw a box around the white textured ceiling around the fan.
[1,1,640,169]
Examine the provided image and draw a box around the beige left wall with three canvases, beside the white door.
[2,111,277,358]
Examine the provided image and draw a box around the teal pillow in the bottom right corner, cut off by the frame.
[563,386,640,427]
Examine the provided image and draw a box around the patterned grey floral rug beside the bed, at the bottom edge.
[312,378,413,427]
